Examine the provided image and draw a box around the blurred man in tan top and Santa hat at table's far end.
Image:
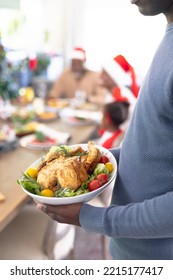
[48,47,105,104]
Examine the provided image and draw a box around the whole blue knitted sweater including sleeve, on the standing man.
[80,24,173,260]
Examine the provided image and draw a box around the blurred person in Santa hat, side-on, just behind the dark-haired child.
[99,55,139,130]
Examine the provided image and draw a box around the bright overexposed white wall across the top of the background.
[0,0,166,80]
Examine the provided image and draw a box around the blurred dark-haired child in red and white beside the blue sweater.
[97,101,129,149]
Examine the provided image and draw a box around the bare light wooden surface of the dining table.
[0,119,96,231]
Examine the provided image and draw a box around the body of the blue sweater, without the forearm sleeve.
[110,25,173,259]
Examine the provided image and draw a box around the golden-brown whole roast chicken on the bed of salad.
[37,141,101,191]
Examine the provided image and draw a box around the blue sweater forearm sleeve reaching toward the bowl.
[80,189,173,239]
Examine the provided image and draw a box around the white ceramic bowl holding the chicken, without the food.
[21,144,117,205]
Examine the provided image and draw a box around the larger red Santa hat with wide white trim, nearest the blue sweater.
[103,55,139,97]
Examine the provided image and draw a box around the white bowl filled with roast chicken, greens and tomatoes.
[17,141,117,205]
